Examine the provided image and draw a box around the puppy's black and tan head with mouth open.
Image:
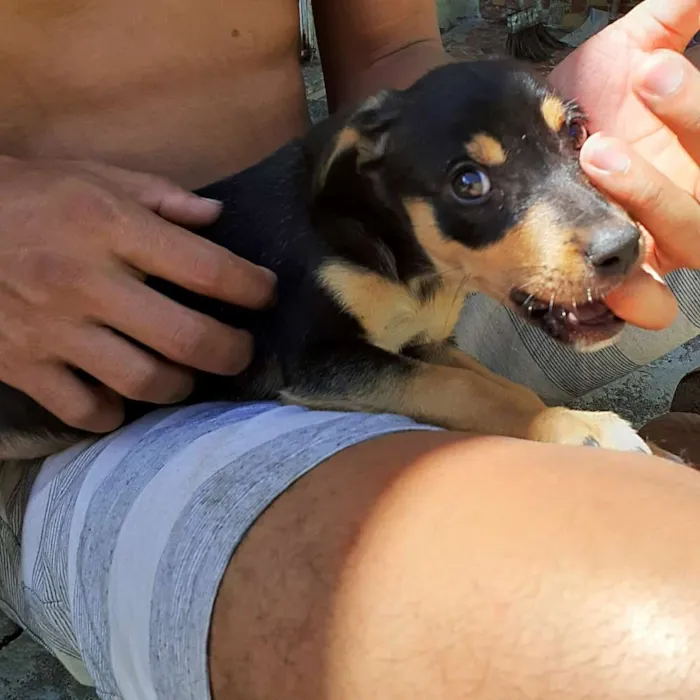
[314,61,643,350]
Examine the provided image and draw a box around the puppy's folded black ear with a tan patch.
[310,91,401,194]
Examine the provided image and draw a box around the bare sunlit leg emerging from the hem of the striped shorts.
[210,434,700,700]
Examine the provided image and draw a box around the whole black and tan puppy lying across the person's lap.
[0,61,660,457]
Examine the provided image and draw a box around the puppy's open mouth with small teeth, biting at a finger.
[510,289,625,352]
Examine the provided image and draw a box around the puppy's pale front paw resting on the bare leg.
[529,408,652,455]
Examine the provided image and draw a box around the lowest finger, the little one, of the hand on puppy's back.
[7,363,124,433]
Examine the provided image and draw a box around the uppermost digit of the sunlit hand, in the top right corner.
[615,0,700,52]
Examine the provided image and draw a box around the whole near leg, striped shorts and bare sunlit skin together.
[5,396,700,700]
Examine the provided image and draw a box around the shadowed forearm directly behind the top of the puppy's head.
[328,41,452,111]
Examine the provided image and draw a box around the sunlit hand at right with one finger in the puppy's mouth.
[552,0,700,329]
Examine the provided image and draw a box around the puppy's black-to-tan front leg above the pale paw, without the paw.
[282,341,547,438]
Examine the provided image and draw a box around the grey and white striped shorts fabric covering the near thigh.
[0,403,430,700]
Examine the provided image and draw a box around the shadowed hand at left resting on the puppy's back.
[0,158,275,432]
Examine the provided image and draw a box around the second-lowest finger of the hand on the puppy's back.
[53,326,193,404]
